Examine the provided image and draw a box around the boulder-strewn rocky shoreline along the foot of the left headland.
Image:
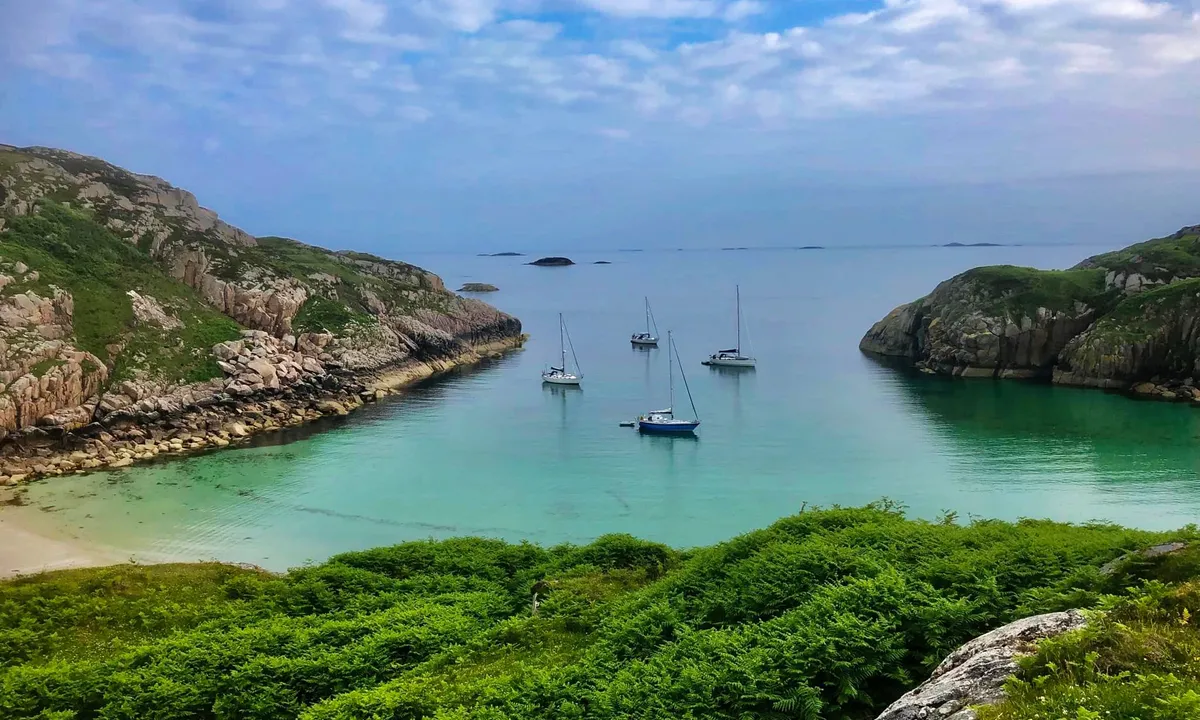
[0,330,526,486]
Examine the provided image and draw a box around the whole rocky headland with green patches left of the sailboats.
[0,145,523,484]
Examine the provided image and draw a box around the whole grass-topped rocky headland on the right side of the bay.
[859,226,1200,402]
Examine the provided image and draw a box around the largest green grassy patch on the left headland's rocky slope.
[0,202,238,380]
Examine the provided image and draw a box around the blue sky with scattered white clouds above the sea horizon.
[0,0,1200,257]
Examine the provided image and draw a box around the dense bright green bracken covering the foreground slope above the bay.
[0,506,1196,720]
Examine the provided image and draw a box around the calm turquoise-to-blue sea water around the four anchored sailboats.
[9,246,1200,569]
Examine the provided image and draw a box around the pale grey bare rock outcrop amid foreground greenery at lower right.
[877,610,1087,720]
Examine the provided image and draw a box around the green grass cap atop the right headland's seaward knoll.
[962,265,1115,316]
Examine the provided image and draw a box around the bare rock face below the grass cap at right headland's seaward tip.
[859,274,1096,377]
